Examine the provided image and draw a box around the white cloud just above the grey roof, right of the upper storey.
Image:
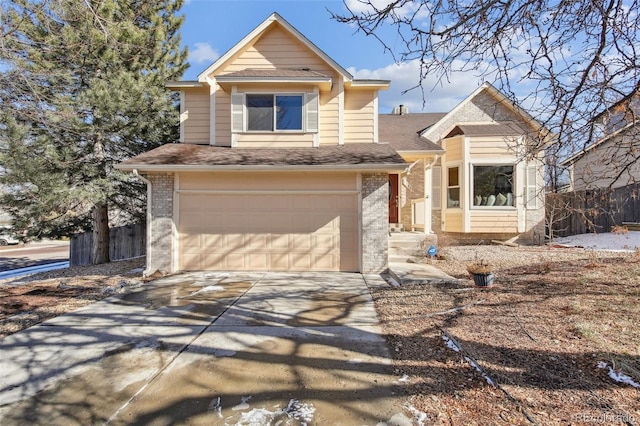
[348,61,484,114]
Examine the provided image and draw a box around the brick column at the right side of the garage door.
[361,173,389,274]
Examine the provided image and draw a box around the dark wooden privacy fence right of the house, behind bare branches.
[545,184,640,237]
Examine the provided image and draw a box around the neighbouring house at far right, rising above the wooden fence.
[562,91,640,191]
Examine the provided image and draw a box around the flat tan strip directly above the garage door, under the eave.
[179,172,357,191]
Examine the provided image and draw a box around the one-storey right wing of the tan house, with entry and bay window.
[379,83,547,243]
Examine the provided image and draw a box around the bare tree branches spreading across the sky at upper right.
[333,0,640,181]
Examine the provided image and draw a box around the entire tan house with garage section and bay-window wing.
[118,14,544,273]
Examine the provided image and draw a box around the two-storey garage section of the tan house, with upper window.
[118,14,407,273]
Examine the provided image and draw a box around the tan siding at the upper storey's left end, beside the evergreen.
[181,87,210,144]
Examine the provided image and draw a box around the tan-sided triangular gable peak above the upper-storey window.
[198,13,353,82]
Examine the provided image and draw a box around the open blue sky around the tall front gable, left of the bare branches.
[182,0,490,113]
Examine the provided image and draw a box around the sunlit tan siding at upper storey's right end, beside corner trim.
[344,91,375,143]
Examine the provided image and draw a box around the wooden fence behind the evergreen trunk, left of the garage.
[69,223,147,266]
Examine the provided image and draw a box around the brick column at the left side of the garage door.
[146,173,174,274]
